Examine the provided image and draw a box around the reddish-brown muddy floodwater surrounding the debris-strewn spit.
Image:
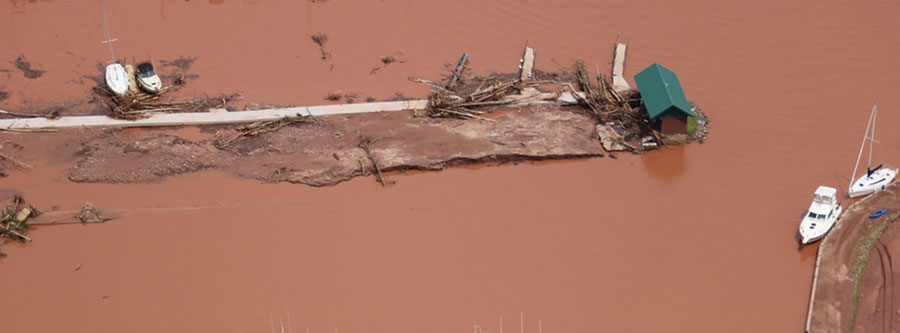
[0,0,900,332]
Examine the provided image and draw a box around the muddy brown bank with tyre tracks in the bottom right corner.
[807,183,900,332]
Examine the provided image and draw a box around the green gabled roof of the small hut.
[634,63,694,119]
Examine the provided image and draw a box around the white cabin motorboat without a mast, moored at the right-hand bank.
[799,186,843,244]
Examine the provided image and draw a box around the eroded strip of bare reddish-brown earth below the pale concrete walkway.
[66,105,604,186]
